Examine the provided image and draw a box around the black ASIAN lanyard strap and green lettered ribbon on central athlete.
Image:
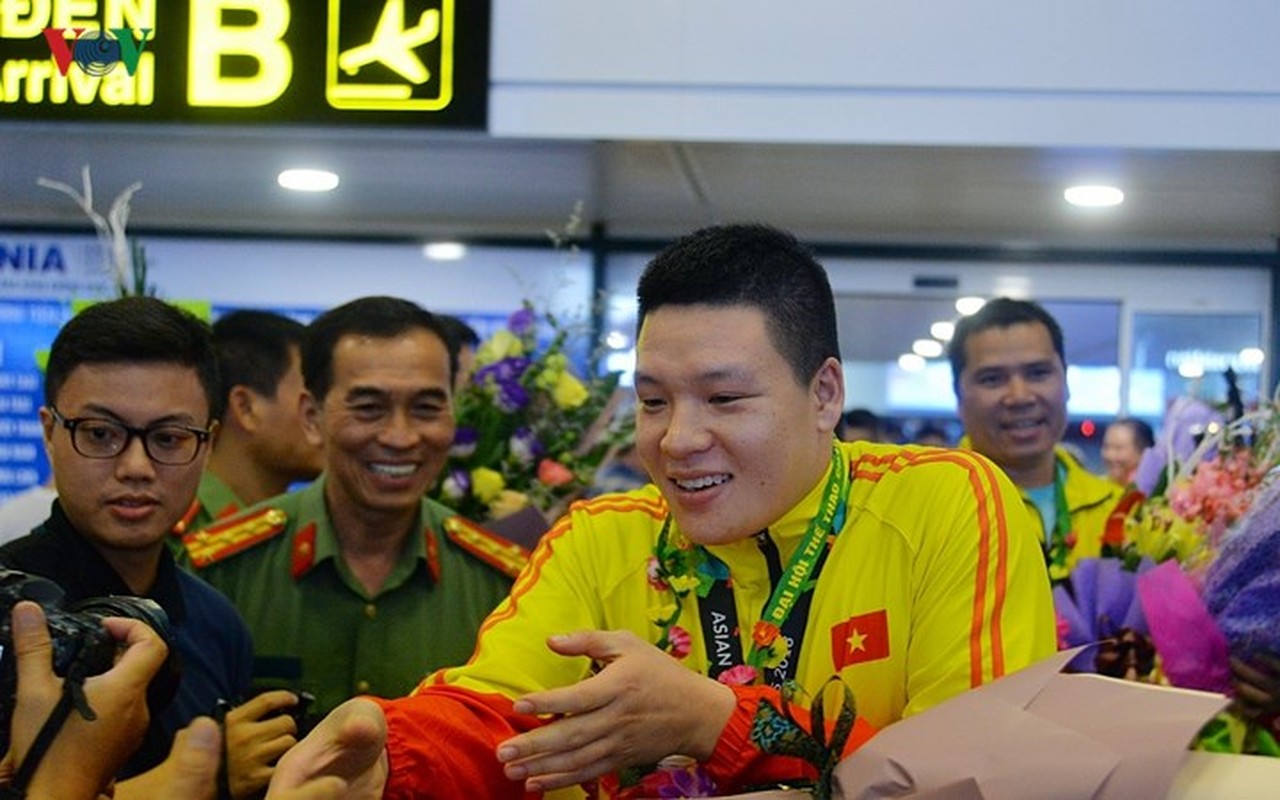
[698,445,850,687]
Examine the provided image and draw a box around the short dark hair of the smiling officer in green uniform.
[302,296,458,401]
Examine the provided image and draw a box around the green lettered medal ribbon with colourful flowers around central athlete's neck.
[649,443,851,682]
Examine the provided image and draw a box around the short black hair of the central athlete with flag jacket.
[636,224,840,385]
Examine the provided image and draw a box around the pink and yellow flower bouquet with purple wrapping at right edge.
[1059,381,1280,755]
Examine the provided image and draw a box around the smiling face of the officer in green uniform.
[303,328,454,516]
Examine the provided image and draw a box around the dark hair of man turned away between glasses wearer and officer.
[214,310,306,397]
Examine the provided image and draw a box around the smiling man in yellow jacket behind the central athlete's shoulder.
[947,297,1129,581]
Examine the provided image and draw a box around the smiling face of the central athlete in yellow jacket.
[636,305,845,544]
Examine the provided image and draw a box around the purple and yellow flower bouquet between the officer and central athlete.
[433,302,631,522]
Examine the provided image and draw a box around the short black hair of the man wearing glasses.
[45,297,225,421]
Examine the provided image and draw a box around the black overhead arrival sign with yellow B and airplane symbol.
[0,0,489,128]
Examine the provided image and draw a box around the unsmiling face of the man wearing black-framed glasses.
[40,362,209,562]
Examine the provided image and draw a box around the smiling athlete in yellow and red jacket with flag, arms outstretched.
[273,225,1055,797]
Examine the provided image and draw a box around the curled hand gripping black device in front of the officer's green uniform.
[224,690,298,797]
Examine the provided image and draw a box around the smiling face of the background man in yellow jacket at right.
[957,323,1068,488]
